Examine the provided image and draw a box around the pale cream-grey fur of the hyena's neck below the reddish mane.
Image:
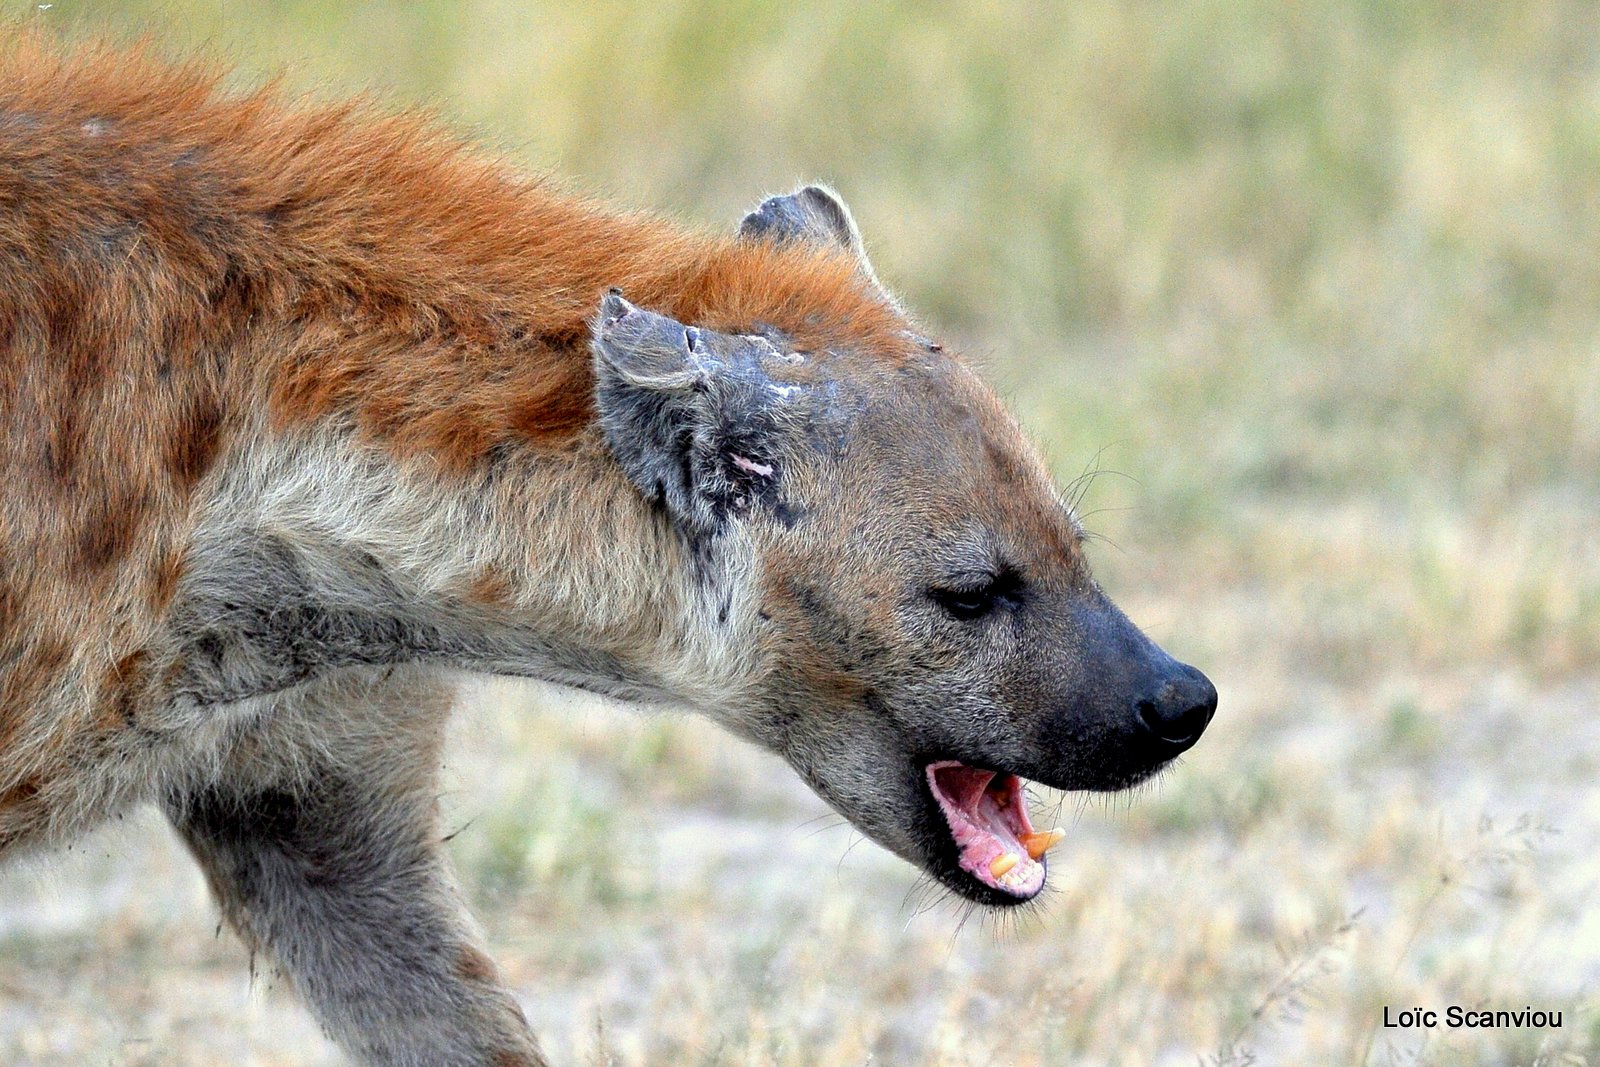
[168,424,760,709]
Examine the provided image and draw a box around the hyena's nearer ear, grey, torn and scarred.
[594,290,797,534]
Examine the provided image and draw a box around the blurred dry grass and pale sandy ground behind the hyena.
[0,0,1600,1065]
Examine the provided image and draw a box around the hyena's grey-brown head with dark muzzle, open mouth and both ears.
[595,187,1216,905]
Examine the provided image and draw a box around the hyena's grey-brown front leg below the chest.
[170,671,544,1067]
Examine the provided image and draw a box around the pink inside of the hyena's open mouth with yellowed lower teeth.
[928,760,1066,897]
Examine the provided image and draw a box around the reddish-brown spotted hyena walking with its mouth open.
[0,40,1216,1064]
